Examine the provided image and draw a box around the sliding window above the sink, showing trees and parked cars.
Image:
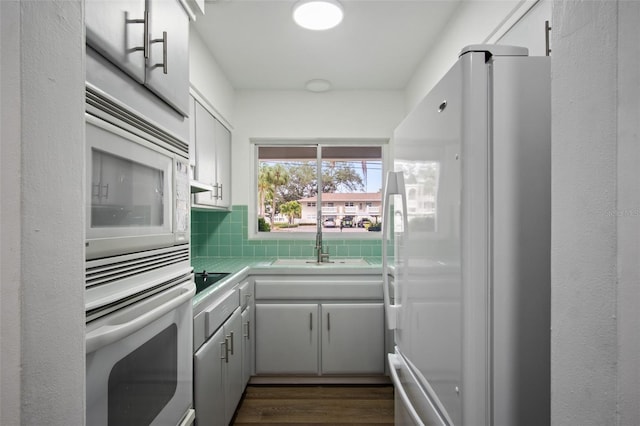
[256,143,383,234]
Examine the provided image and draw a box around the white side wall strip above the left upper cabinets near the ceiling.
[189,26,235,128]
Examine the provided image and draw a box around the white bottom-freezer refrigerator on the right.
[383,45,551,426]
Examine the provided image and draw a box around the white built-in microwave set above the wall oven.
[85,113,190,260]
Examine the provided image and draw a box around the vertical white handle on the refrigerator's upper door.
[381,172,408,330]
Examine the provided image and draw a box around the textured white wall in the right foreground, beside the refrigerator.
[552,0,640,426]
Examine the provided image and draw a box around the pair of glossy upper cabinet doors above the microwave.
[85,0,189,116]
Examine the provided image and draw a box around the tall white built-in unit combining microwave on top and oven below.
[84,57,196,426]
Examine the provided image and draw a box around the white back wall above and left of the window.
[232,91,405,204]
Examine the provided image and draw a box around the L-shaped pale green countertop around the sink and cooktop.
[191,257,382,311]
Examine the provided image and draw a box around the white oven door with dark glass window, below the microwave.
[86,275,195,426]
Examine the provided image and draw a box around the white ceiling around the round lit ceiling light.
[195,0,460,90]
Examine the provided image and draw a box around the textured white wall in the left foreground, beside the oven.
[0,0,85,425]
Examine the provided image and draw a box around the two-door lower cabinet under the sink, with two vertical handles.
[256,303,385,375]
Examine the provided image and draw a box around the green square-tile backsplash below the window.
[191,205,382,258]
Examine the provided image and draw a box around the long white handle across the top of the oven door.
[85,280,196,353]
